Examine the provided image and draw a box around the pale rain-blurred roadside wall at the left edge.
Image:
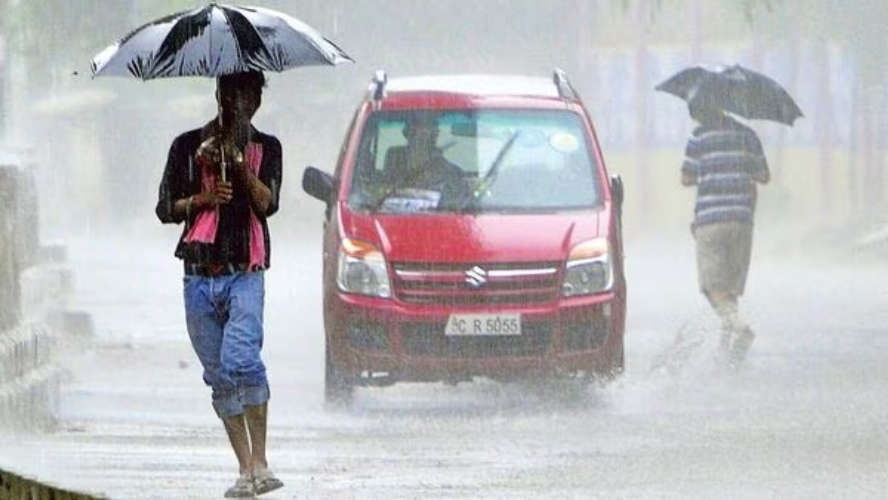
[0,158,71,430]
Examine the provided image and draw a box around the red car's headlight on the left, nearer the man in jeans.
[336,238,392,298]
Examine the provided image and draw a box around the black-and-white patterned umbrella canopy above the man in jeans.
[91,3,352,80]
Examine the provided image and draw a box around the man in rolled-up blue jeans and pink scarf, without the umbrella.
[156,72,283,497]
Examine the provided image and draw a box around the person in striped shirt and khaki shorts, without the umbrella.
[681,100,770,365]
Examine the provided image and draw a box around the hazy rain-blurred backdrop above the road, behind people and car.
[0,0,888,251]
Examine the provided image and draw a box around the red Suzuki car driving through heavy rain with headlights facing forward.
[303,70,626,402]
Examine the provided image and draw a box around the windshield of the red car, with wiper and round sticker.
[348,110,601,214]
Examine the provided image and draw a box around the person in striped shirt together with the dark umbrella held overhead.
[656,65,801,367]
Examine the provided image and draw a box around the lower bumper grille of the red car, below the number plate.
[401,323,552,358]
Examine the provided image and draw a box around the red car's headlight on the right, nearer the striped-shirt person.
[561,238,614,297]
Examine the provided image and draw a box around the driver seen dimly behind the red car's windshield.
[383,114,469,209]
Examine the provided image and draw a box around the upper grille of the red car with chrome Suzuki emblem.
[393,262,560,306]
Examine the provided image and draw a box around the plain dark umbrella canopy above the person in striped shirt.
[654,65,802,125]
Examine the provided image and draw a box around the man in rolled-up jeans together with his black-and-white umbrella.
[91,3,351,497]
